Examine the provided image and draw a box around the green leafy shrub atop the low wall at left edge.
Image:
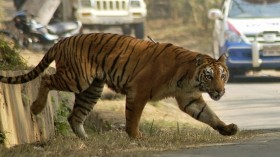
[0,39,27,70]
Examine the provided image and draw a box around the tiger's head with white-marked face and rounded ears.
[196,55,229,100]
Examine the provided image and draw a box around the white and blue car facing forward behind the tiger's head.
[208,0,280,75]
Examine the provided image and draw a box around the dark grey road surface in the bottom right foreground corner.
[154,132,280,157]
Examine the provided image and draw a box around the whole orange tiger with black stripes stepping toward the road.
[0,33,238,139]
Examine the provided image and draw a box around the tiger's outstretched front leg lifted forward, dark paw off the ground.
[176,95,238,136]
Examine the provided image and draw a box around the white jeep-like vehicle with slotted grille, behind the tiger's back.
[76,0,147,38]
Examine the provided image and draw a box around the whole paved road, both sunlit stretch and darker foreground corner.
[155,72,280,157]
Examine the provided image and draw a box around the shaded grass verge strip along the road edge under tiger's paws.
[0,123,259,157]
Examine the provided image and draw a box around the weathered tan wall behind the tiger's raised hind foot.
[0,71,57,147]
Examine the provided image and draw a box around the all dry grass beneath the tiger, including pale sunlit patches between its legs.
[0,90,261,157]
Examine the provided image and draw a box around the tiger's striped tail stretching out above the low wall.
[0,48,55,84]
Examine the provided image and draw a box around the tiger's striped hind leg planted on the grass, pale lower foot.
[68,79,104,138]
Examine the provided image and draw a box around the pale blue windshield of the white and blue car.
[228,0,280,18]
